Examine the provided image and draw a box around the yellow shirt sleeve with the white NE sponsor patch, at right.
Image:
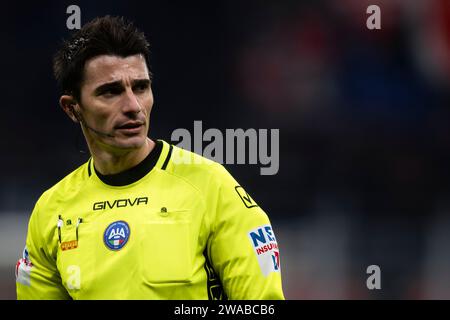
[208,165,284,300]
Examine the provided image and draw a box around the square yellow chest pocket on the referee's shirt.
[140,208,193,283]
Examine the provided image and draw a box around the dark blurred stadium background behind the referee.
[0,0,450,299]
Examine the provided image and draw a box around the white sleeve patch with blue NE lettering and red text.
[248,225,280,276]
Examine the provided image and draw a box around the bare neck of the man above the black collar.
[90,138,155,175]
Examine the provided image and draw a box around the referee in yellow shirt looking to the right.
[16,16,284,299]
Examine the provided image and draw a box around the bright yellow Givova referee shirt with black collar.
[16,140,284,299]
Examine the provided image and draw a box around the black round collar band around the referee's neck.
[94,140,163,187]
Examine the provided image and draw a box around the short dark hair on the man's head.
[53,16,151,101]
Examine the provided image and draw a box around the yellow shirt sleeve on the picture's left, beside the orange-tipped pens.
[16,202,70,300]
